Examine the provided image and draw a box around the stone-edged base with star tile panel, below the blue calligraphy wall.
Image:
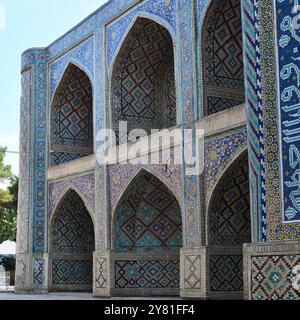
[244,241,300,300]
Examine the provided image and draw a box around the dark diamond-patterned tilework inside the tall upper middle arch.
[113,18,176,130]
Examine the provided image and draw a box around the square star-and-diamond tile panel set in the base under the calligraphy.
[251,255,300,300]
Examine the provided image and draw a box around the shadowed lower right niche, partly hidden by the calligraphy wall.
[207,151,251,298]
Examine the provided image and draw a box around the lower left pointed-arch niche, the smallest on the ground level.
[49,189,95,291]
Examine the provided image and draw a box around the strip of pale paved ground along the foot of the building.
[0,292,180,301]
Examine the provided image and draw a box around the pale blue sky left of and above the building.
[0,0,106,174]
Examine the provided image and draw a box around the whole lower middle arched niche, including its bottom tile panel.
[112,170,182,295]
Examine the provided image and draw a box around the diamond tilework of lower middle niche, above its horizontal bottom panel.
[115,172,182,251]
